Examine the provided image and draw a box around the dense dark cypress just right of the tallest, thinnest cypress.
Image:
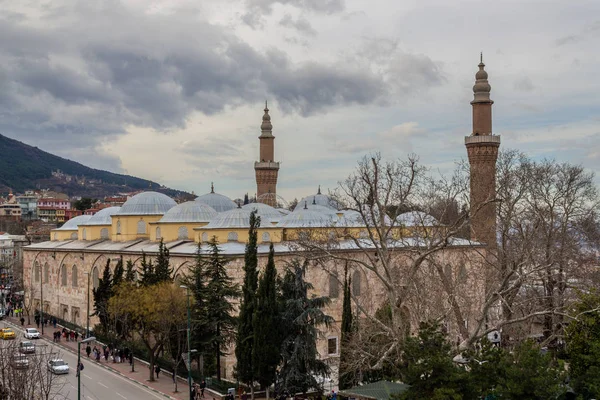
[252,243,281,400]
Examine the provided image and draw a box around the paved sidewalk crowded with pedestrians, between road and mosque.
[4,317,189,400]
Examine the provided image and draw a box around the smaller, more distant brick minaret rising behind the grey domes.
[254,101,279,207]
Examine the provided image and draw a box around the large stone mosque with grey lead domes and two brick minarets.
[23,58,500,378]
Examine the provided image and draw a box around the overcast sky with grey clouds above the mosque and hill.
[0,0,600,200]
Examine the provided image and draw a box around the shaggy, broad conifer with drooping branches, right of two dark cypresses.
[278,259,333,394]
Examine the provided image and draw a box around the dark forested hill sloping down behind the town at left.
[0,135,187,198]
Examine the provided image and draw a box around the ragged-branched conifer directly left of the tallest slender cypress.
[201,237,239,380]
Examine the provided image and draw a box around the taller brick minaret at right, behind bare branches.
[465,56,500,247]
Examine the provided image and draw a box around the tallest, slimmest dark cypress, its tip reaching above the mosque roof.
[235,211,260,390]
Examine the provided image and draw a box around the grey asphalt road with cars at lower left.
[0,322,164,400]
